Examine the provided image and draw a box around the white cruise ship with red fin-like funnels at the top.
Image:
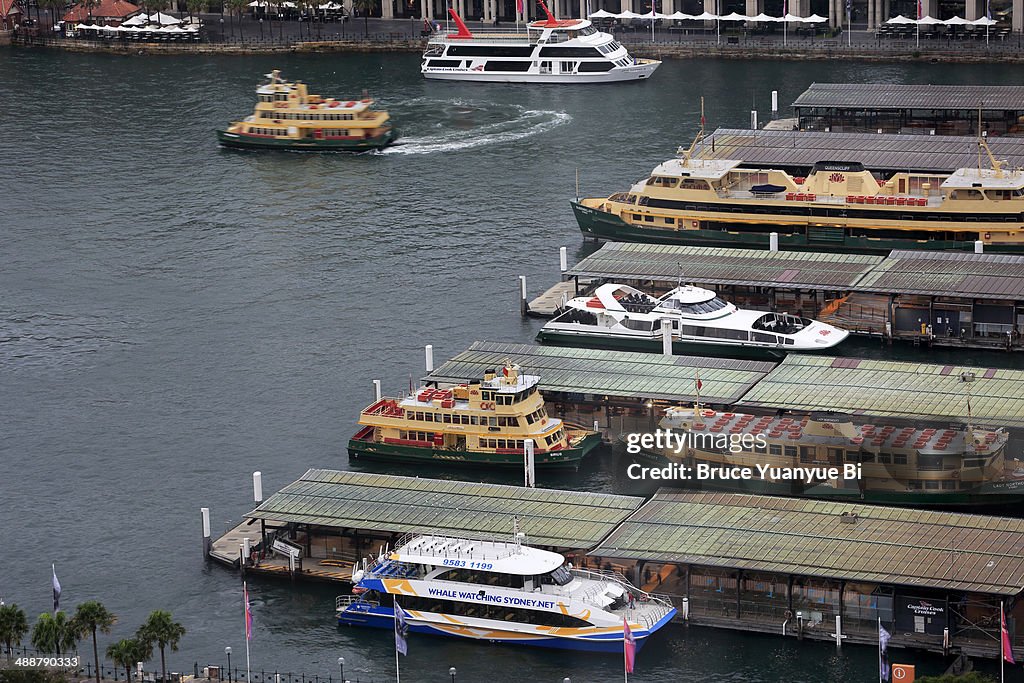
[421,1,662,83]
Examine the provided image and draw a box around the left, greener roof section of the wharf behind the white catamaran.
[568,242,885,290]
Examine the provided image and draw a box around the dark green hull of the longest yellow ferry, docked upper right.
[571,202,1024,254]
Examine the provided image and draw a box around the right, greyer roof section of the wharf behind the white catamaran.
[856,251,1024,299]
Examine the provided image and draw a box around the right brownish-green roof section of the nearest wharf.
[591,489,1024,595]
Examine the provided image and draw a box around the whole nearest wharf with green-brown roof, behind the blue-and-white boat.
[211,469,1024,657]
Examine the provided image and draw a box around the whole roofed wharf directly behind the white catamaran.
[530,243,1024,350]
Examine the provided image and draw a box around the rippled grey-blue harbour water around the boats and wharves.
[6,50,1024,683]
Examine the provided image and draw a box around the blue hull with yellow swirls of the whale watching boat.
[338,605,676,656]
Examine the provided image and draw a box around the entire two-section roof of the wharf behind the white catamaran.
[568,242,1024,301]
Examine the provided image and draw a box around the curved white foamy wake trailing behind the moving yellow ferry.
[379,98,572,155]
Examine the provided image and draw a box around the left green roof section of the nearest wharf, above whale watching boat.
[246,469,643,549]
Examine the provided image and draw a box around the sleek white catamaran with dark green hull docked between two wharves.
[537,283,850,357]
